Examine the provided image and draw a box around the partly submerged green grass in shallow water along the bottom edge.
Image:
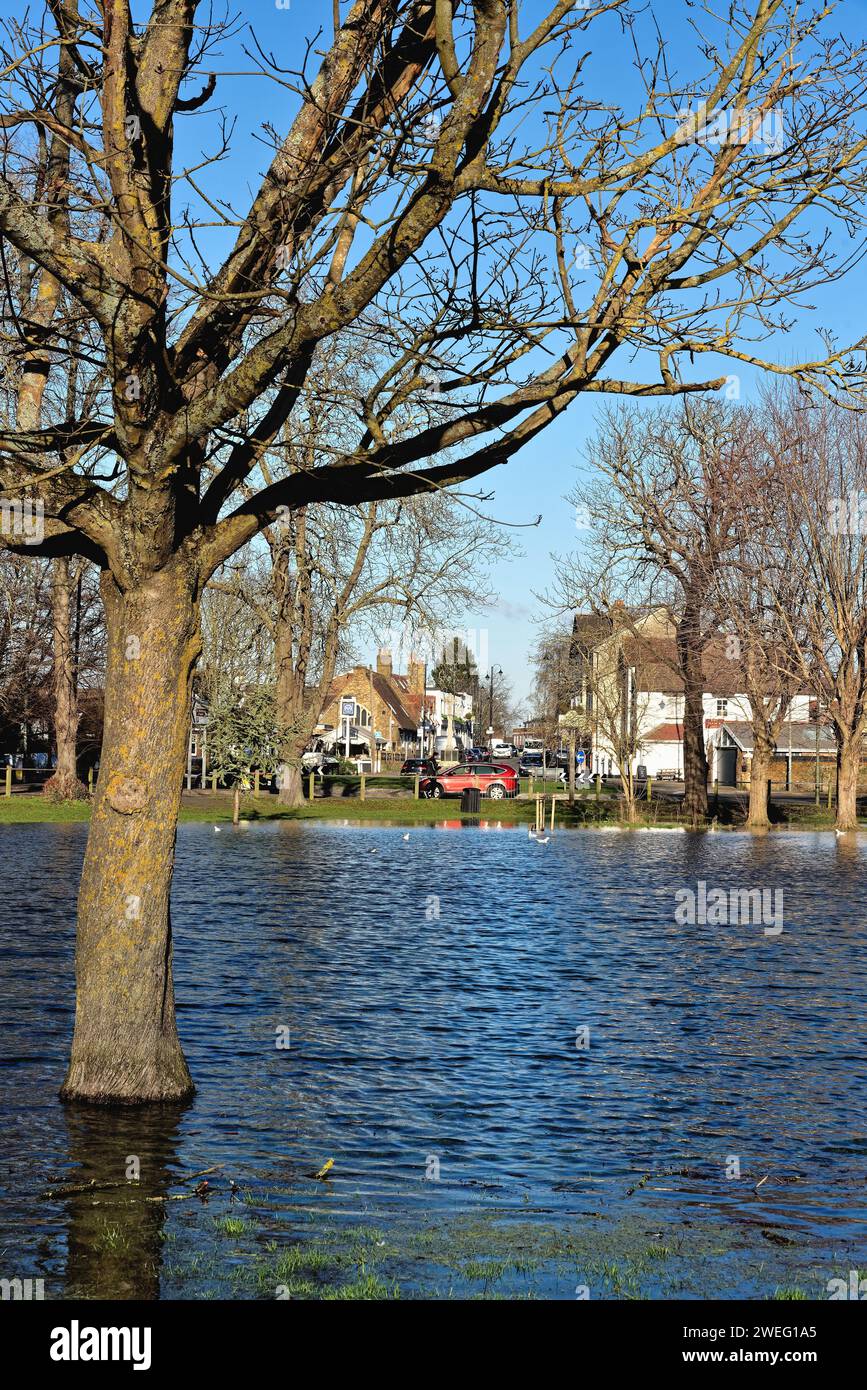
[157,1209,828,1301]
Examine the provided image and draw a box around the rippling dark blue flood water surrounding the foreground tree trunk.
[0,823,867,1298]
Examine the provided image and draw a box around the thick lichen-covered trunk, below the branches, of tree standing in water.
[61,562,200,1104]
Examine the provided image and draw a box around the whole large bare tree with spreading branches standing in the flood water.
[0,0,867,1102]
